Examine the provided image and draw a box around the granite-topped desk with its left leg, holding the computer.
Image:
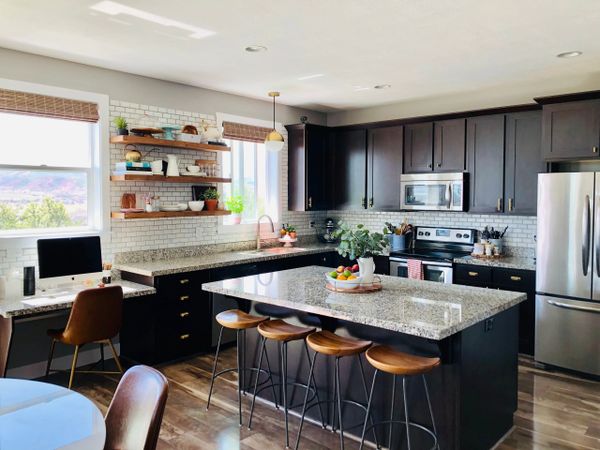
[0,280,156,376]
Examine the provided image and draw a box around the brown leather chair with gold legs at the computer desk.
[46,286,123,389]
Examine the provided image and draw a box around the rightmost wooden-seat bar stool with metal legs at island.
[360,345,440,450]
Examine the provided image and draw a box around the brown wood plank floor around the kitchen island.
[51,349,600,450]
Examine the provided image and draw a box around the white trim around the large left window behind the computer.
[0,78,110,249]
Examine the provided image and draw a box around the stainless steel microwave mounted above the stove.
[400,172,468,211]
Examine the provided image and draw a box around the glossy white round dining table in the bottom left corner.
[0,378,106,450]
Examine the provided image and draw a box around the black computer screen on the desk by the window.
[38,236,102,278]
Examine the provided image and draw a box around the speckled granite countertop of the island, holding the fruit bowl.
[202,266,527,340]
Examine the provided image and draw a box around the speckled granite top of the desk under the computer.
[0,280,156,318]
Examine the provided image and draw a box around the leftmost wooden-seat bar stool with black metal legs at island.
[206,309,277,426]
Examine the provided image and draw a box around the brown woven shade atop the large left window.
[0,89,98,122]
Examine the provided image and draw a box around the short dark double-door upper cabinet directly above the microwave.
[404,119,465,173]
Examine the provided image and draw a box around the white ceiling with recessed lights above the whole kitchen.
[0,0,600,111]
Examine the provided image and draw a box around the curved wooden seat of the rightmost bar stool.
[365,345,440,375]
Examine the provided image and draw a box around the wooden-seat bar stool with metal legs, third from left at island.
[295,330,379,450]
